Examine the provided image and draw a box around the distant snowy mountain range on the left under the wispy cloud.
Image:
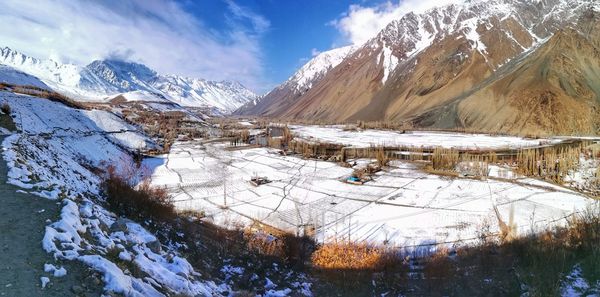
[0,47,257,113]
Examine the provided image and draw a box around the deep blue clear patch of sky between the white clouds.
[188,0,375,88]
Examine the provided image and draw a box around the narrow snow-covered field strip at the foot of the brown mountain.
[289,125,562,149]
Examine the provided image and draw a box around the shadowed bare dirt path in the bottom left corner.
[0,138,103,296]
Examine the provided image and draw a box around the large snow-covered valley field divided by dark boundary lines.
[147,141,591,248]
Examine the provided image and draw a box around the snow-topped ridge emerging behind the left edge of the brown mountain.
[236,46,357,115]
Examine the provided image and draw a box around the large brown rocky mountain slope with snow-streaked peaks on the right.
[241,0,600,134]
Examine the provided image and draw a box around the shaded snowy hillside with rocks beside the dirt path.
[0,92,247,296]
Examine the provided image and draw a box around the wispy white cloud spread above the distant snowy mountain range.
[0,0,270,89]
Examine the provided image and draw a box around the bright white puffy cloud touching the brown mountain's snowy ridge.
[331,0,464,44]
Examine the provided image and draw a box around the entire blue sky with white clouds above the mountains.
[0,0,452,93]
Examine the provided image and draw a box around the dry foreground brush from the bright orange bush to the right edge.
[304,207,600,296]
